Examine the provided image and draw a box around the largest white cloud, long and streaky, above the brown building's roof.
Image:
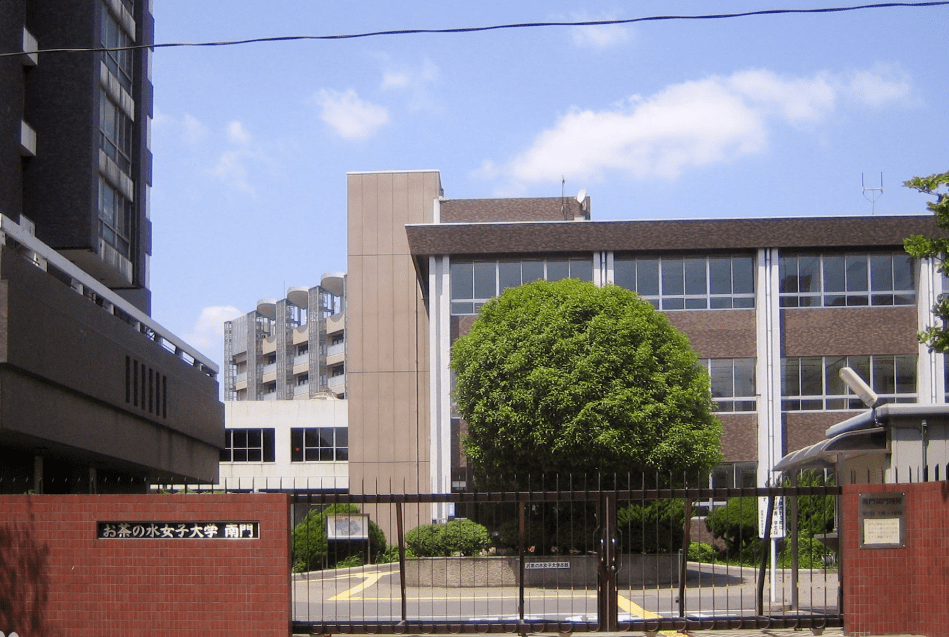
[500,70,912,185]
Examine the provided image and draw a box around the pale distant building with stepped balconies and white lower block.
[220,273,349,492]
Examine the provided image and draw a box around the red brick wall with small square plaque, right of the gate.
[841,482,949,637]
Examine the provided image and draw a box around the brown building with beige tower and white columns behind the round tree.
[347,170,946,506]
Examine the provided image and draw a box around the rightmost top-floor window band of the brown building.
[779,252,916,307]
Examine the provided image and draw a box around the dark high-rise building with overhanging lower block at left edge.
[0,0,223,493]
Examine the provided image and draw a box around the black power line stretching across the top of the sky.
[0,0,949,57]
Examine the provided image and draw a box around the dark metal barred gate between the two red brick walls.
[292,478,842,634]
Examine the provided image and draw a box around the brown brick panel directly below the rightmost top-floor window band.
[781,307,918,356]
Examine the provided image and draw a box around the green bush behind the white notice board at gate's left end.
[292,504,386,572]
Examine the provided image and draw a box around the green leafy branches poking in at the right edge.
[903,172,949,352]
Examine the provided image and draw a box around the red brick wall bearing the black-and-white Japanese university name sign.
[0,494,291,637]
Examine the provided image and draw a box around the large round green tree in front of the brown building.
[451,279,721,485]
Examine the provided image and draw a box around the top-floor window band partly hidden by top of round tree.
[451,258,593,315]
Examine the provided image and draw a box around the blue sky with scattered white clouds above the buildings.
[150,0,949,365]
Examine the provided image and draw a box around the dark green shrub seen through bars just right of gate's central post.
[616,500,685,555]
